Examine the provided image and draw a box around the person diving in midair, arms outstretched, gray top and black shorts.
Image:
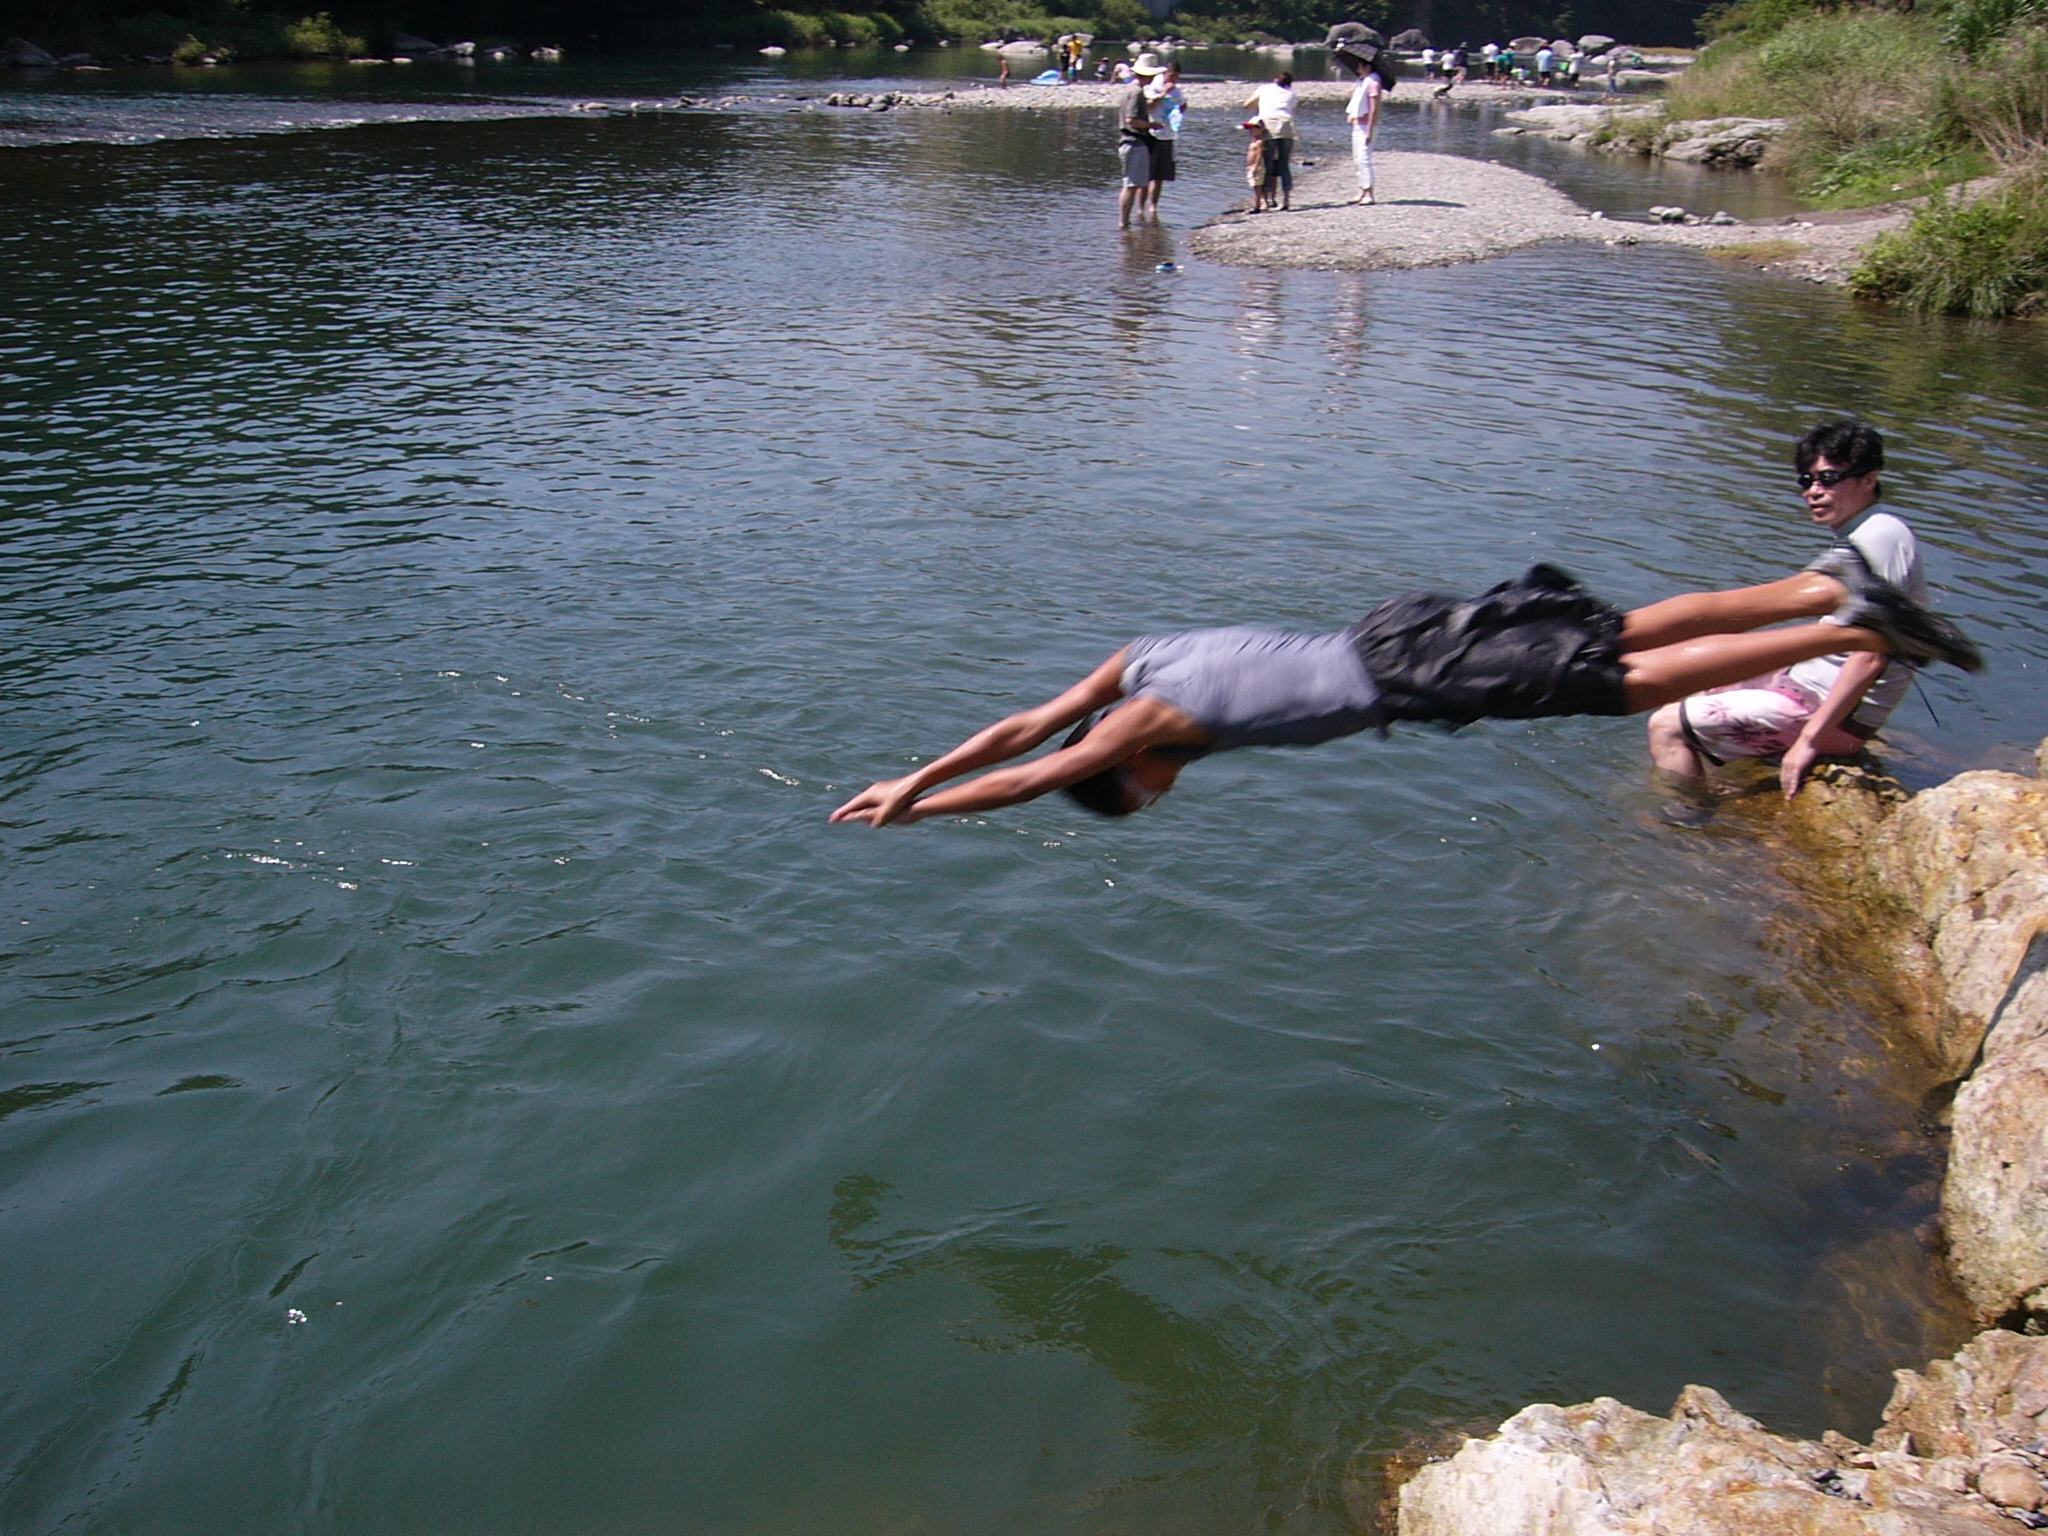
[831,565,1985,827]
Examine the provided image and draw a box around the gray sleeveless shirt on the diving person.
[1124,629,1382,752]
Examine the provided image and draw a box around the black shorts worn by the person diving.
[1352,565,1628,727]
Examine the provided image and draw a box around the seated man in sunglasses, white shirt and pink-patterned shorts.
[1649,422,1927,807]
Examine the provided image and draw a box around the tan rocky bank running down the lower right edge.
[1397,741,2048,1536]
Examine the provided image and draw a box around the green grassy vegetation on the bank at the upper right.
[1662,0,2048,315]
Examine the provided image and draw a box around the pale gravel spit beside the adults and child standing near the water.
[1190,152,1907,283]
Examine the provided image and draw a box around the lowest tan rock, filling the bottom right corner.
[1399,1331,2048,1536]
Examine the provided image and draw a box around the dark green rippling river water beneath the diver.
[12,55,2048,1536]
